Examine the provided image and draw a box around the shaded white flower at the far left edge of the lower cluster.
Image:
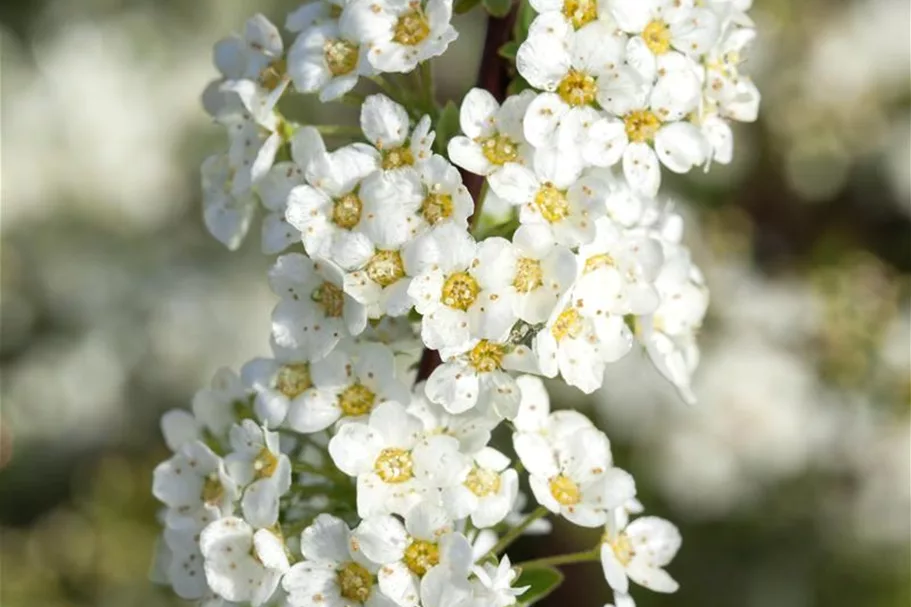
[152,440,240,526]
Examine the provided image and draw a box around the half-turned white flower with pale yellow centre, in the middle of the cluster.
[502,224,576,325]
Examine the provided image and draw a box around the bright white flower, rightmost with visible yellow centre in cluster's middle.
[573,217,664,315]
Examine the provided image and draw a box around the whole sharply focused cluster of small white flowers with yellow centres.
[153,0,758,607]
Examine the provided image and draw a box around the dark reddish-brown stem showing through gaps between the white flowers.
[416,3,518,381]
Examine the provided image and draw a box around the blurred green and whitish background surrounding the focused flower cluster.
[0,0,911,607]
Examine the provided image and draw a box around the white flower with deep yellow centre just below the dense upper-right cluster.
[489,150,605,247]
